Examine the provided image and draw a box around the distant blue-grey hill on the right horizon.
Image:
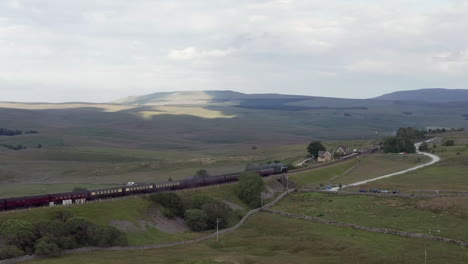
[374,88,468,103]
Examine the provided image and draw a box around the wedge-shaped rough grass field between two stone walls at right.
[274,193,468,242]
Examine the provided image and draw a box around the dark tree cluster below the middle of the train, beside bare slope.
[150,193,240,231]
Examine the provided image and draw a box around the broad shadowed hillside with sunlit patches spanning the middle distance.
[0,91,468,151]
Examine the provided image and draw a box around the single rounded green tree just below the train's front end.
[236,173,265,207]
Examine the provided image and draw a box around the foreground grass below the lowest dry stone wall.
[23,213,468,264]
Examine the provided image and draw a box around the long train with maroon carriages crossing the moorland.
[0,166,288,211]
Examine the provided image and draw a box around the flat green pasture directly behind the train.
[0,137,371,197]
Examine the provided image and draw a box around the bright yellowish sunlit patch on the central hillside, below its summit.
[138,106,236,119]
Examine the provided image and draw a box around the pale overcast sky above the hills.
[0,0,468,102]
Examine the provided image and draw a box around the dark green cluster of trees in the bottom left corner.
[0,210,128,260]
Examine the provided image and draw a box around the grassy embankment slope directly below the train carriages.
[0,184,250,245]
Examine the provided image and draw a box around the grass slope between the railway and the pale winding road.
[290,154,429,187]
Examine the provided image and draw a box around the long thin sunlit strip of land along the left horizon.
[0,103,135,112]
